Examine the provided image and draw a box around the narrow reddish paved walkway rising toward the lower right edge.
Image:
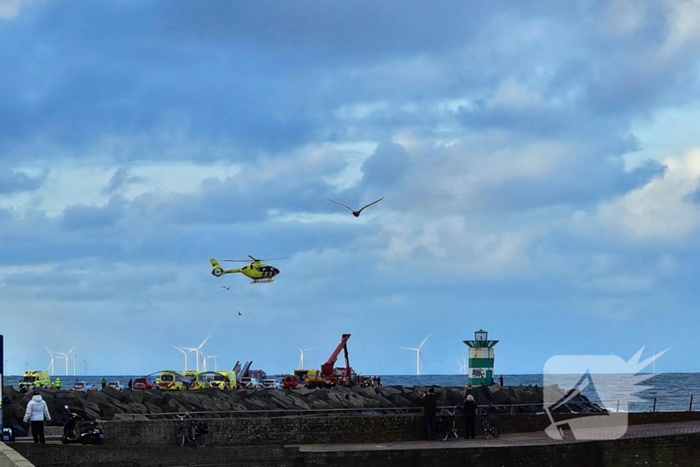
[299,421,700,452]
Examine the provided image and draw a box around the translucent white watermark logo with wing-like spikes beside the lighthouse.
[543,347,669,440]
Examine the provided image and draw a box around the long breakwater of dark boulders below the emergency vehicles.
[4,385,604,436]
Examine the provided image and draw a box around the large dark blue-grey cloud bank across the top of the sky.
[0,1,697,162]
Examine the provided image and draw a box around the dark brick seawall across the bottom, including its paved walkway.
[0,412,700,467]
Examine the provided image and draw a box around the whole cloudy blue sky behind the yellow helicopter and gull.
[0,0,700,375]
